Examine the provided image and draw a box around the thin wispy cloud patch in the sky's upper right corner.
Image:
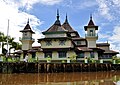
[96,0,120,21]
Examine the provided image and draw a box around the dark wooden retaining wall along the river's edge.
[0,62,120,73]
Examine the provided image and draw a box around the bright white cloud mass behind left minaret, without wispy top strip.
[0,0,42,46]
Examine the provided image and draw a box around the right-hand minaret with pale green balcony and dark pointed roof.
[84,15,98,48]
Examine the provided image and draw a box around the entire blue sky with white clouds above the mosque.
[0,0,120,52]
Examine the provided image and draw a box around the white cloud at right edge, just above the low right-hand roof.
[99,26,120,52]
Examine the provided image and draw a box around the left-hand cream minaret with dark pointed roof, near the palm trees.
[20,19,35,51]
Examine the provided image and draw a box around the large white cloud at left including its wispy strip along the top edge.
[0,0,62,45]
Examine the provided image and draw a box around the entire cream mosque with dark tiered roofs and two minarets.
[16,11,118,63]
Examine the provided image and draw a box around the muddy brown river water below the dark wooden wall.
[0,71,120,85]
